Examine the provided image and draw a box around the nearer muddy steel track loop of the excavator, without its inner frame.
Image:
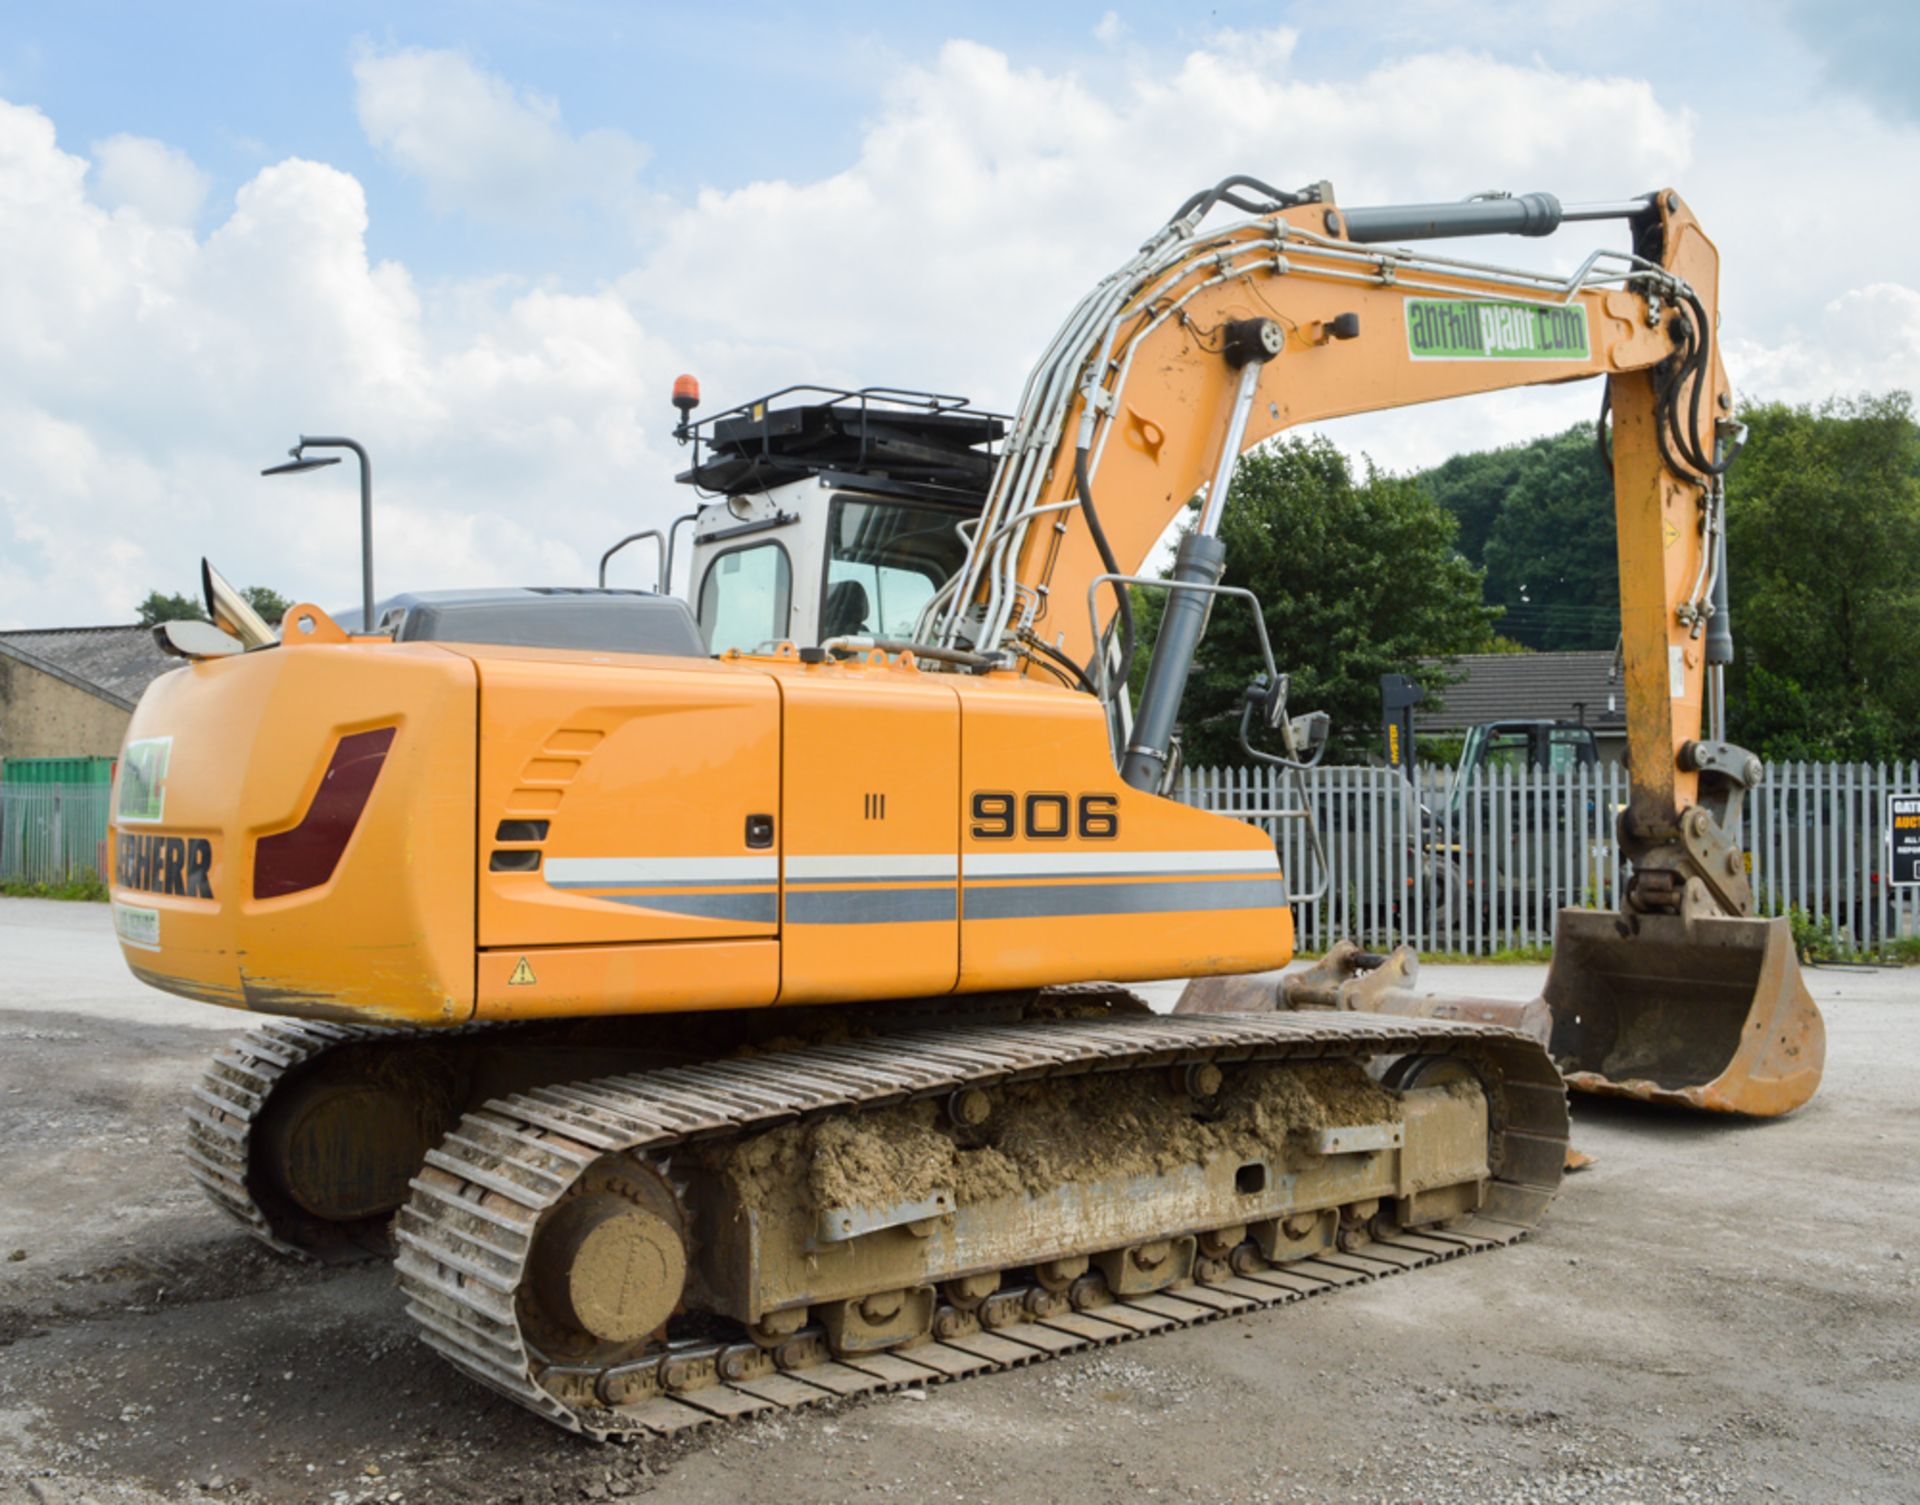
[382,1014,1567,1438]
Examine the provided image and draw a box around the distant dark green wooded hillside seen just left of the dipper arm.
[1421,424,1620,651]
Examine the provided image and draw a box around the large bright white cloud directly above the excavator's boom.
[620,31,1693,463]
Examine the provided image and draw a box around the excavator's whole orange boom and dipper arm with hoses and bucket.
[936,182,1824,1113]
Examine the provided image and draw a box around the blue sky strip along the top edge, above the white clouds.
[11,0,1920,275]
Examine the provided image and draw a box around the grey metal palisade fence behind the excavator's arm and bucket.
[1175,762,1920,956]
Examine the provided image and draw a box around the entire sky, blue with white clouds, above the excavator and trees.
[0,0,1920,626]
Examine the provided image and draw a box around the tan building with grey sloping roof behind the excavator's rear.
[0,624,180,758]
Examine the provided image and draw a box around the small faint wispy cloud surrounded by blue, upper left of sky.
[353,48,649,223]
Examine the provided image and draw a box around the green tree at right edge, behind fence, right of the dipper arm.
[1726,392,1920,760]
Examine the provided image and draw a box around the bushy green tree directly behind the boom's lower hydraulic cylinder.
[1135,438,1498,764]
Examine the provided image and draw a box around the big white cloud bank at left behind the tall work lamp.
[0,106,674,626]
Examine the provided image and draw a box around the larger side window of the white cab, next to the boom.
[820,497,972,643]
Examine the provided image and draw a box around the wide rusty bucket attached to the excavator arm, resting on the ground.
[1546,910,1826,1117]
